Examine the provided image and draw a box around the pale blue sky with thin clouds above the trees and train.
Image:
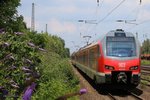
[18,0,150,52]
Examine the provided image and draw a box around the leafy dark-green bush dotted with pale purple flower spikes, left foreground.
[0,32,40,98]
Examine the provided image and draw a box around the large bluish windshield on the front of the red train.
[106,37,136,57]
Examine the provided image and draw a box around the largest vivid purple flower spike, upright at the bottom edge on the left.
[22,82,36,100]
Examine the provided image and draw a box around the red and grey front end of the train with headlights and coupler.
[101,30,140,86]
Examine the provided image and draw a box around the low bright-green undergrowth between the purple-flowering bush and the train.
[33,52,79,100]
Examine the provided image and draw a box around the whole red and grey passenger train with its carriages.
[71,29,141,86]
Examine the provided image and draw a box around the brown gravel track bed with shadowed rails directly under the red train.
[74,64,148,100]
